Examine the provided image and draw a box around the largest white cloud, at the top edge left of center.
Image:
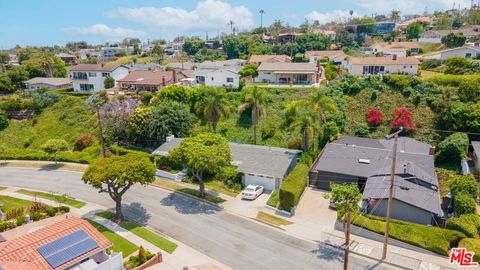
[105,0,253,33]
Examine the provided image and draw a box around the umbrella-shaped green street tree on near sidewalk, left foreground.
[82,154,157,221]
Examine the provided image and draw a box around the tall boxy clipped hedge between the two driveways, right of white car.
[279,164,309,212]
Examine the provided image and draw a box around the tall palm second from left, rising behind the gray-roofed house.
[238,86,267,144]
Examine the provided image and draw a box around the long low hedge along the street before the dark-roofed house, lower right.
[352,215,466,256]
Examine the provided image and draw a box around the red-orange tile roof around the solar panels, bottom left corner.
[0,217,112,270]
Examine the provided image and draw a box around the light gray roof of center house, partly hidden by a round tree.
[153,138,301,179]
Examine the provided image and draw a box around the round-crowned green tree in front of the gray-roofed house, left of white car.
[170,133,232,198]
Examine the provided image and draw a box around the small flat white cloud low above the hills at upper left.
[62,24,145,41]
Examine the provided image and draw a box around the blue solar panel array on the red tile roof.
[37,230,98,268]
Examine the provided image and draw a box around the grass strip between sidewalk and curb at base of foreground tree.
[96,211,177,254]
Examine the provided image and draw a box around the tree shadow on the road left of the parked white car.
[160,192,218,215]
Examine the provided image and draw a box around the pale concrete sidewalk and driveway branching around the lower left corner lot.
[0,187,231,270]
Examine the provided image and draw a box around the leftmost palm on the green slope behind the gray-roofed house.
[195,89,230,133]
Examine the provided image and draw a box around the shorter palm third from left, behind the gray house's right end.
[290,108,319,151]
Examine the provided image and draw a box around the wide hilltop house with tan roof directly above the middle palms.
[255,63,320,85]
